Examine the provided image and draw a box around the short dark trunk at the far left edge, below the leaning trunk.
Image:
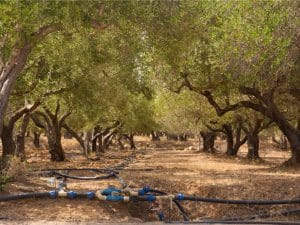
[1,125,16,157]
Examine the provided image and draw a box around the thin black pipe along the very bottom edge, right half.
[165,220,300,225]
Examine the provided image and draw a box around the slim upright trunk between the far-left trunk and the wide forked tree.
[16,114,30,161]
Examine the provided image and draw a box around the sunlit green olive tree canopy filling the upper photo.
[0,0,300,141]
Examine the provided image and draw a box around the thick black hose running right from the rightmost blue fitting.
[182,195,300,205]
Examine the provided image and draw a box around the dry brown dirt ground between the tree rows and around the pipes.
[0,137,300,224]
